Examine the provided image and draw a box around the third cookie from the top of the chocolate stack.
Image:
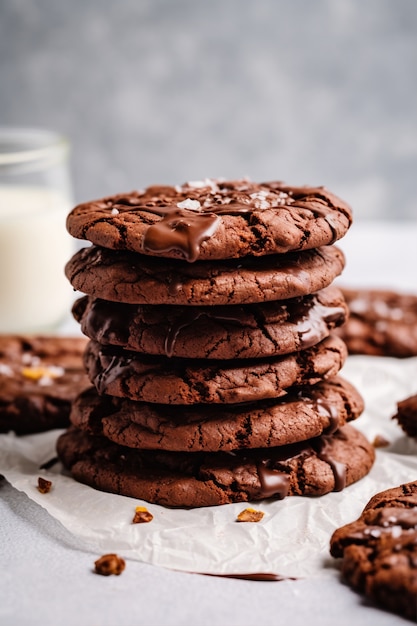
[73,286,347,359]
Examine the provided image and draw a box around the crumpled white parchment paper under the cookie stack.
[0,356,417,578]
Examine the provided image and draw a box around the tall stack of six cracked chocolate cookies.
[57,180,374,507]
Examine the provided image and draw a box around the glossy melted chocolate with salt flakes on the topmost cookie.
[106,180,344,262]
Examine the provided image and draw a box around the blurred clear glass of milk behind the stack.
[0,127,74,333]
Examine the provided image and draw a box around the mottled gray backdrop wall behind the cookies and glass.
[0,0,417,218]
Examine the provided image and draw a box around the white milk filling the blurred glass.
[0,185,74,333]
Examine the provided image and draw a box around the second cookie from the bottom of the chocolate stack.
[71,378,363,452]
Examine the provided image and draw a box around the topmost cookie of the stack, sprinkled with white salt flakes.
[67,179,352,262]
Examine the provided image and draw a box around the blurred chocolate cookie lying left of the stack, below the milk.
[0,335,89,435]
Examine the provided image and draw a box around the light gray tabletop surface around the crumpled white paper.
[0,223,417,626]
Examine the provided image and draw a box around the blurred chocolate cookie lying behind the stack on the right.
[338,289,417,357]
